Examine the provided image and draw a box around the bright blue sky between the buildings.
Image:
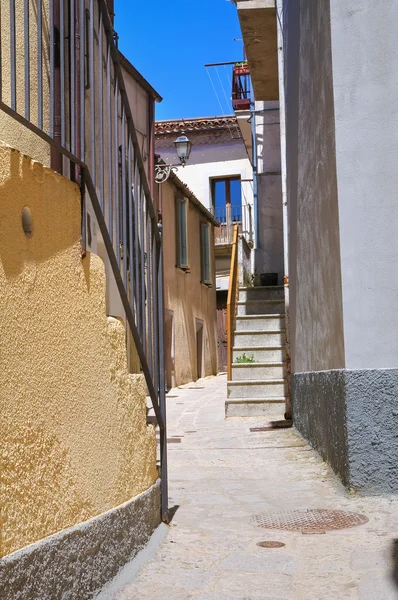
[115,0,243,119]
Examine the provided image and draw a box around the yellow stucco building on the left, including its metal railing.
[0,0,167,600]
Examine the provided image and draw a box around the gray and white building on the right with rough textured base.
[236,0,398,493]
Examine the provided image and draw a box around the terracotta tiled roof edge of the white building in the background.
[155,115,242,139]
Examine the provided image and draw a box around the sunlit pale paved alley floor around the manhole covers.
[101,376,398,600]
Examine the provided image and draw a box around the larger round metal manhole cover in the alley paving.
[251,509,369,533]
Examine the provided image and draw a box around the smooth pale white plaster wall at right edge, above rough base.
[330,0,398,369]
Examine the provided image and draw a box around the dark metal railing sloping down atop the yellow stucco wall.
[0,0,167,520]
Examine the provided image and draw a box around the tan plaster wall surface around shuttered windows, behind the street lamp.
[161,180,217,386]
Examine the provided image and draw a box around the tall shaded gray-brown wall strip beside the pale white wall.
[284,0,345,371]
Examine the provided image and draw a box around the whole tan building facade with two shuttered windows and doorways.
[158,173,218,389]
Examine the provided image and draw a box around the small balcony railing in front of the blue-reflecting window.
[214,204,253,246]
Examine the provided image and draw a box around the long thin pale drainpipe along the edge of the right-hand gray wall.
[276,0,292,419]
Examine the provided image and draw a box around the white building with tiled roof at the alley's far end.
[155,116,254,371]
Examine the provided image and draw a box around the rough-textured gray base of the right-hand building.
[292,369,398,494]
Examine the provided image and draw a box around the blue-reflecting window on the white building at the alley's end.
[212,177,242,223]
